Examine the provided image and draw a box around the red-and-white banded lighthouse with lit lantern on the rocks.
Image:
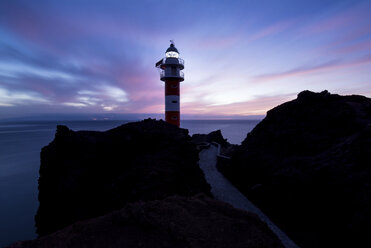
[156,41,184,127]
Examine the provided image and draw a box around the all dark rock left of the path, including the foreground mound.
[10,119,282,247]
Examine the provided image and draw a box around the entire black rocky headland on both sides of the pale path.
[10,91,371,247]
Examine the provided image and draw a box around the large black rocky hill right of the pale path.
[219,91,371,247]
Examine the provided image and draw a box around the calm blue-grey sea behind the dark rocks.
[0,120,260,247]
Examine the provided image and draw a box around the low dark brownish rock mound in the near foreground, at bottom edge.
[10,196,283,248]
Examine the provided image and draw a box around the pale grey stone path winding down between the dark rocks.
[199,144,298,248]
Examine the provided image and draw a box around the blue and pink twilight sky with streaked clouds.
[0,0,371,119]
